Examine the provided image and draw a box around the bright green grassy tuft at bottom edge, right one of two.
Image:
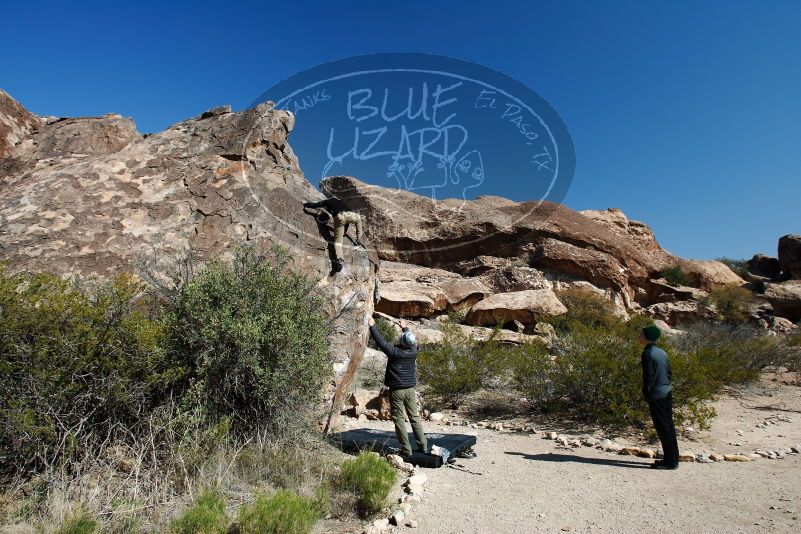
[238,490,318,534]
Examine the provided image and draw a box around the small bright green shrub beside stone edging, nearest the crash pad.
[338,452,397,516]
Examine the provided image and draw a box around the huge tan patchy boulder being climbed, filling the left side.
[0,93,378,430]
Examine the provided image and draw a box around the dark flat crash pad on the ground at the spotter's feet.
[333,428,476,467]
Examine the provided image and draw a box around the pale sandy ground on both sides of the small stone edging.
[336,378,801,534]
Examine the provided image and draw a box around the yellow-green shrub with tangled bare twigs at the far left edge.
[0,271,172,478]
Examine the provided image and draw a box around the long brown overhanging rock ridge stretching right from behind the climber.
[321,176,743,309]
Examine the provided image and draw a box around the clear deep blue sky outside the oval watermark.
[0,0,801,258]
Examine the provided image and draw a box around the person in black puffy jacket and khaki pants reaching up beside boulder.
[368,317,428,456]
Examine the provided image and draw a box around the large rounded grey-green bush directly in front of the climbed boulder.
[167,248,331,438]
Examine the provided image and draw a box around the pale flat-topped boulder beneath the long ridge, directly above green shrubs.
[466,289,567,326]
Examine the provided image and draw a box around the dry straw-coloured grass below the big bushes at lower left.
[0,429,355,533]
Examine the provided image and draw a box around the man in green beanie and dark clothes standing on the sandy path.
[639,325,679,469]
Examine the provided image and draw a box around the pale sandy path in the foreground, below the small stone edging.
[416,431,801,533]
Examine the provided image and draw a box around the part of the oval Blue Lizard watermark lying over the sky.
[253,54,575,206]
